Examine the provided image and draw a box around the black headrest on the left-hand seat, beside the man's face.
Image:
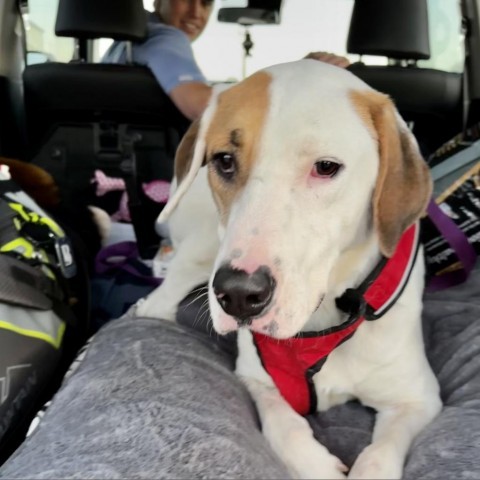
[55,0,147,41]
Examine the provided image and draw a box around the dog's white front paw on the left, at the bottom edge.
[278,432,348,480]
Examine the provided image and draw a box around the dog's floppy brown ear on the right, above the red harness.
[356,92,432,257]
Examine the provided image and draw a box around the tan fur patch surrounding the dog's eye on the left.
[205,72,272,221]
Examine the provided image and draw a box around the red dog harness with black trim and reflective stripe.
[253,223,419,415]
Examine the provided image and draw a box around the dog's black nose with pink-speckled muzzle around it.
[212,265,275,325]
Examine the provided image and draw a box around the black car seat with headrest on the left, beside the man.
[23,0,189,257]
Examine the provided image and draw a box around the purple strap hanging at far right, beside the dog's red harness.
[426,199,477,292]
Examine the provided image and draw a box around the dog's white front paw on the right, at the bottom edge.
[348,444,403,480]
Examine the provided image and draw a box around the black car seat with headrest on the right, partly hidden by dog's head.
[347,0,463,157]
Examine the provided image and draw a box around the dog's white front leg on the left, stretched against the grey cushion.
[236,330,347,479]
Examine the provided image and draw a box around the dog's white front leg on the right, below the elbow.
[348,397,441,479]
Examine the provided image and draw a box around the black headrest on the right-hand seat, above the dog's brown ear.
[347,0,430,60]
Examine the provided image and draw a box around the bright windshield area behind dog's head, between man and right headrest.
[193,0,353,81]
